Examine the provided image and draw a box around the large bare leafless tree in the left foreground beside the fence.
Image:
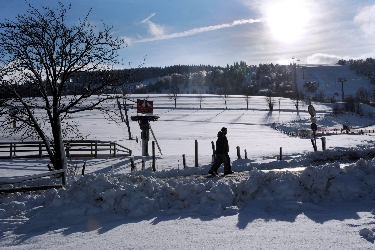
[0,3,130,176]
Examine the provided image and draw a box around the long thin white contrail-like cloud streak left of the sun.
[135,18,261,43]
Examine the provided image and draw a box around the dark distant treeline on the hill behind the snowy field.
[0,61,295,98]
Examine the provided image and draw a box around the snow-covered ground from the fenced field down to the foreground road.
[0,66,375,249]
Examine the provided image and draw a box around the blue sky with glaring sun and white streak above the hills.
[0,0,375,67]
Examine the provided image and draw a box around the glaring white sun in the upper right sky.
[266,0,311,43]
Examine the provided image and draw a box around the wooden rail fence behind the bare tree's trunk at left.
[0,140,132,159]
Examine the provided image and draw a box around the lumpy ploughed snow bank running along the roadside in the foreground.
[0,159,375,222]
